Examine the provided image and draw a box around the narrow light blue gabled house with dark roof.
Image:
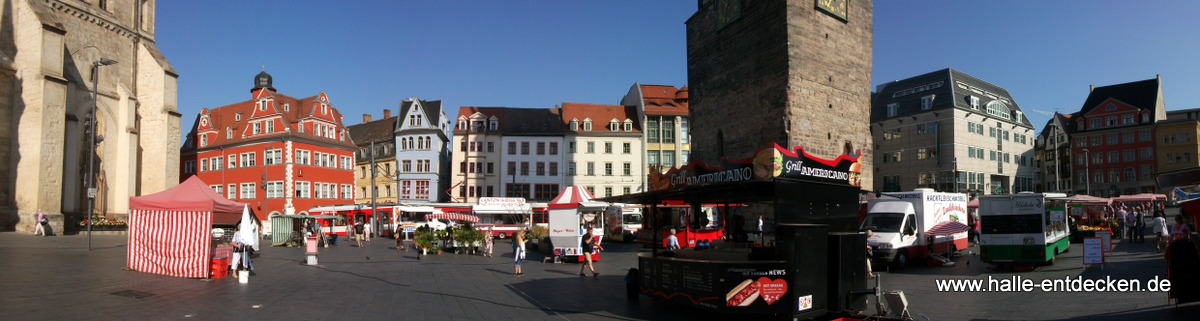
[395,98,452,202]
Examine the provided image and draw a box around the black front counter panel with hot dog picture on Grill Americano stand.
[638,258,792,314]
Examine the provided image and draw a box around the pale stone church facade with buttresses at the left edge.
[0,0,180,234]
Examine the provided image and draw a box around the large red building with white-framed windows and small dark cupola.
[179,72,355,219]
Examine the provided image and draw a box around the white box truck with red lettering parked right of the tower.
[860,188,968,267]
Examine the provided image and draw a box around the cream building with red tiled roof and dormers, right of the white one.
[561,103,648,200]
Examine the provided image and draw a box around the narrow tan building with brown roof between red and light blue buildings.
[346,109,400,205]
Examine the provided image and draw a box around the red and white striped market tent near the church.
[126,176,248,278]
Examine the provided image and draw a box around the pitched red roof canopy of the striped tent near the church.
[130,175,252,225]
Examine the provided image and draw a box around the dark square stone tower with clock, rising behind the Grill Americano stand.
[686,0,874,187]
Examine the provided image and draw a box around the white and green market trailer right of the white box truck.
[979,193,1070,265]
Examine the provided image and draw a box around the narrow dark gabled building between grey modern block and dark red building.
[1033,113,1074,193]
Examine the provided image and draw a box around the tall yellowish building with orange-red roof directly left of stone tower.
[620,84,691,186]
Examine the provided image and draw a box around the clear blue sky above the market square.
[156,0,1200,140]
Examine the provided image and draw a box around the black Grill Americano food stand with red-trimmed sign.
[601,144,871,320]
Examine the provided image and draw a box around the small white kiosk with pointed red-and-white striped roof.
[547,186,610,262]
